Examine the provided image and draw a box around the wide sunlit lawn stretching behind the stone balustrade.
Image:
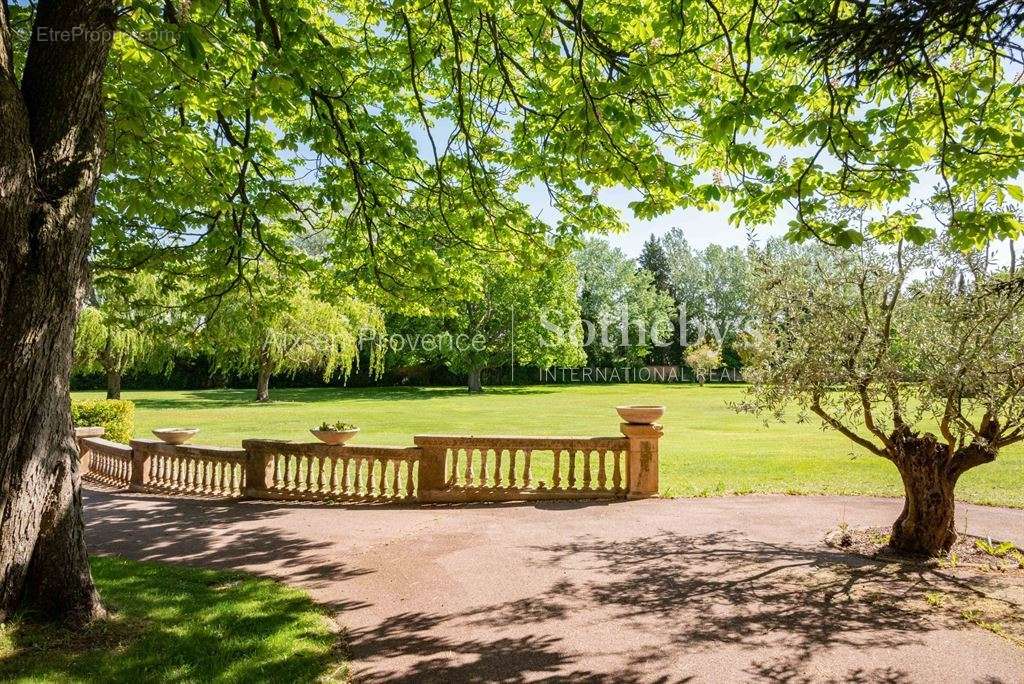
[75,385,1024,507]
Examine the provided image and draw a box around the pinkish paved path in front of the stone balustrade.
[85,490,1024,683]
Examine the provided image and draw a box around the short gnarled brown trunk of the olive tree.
[890,430,995,556]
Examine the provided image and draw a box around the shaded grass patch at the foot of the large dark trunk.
[0,557,346,683]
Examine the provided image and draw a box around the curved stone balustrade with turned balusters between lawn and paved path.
[76,411,662,503]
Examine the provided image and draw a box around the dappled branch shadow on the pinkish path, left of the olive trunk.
[349,531,1015,684]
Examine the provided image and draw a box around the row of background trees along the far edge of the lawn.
[74,228,751,401]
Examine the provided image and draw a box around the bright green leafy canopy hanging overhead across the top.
[12,0,1007,310]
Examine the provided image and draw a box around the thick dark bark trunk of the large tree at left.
[0,0,116,621]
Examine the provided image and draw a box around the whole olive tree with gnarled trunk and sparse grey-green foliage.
[744,243,1024,555]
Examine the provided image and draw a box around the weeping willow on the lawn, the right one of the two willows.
[203,286,384,401]
